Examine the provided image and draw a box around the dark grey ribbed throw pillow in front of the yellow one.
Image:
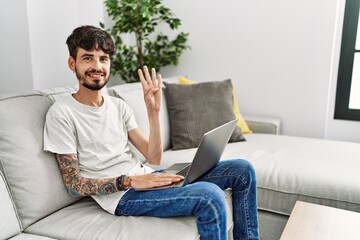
[165,80,245,149]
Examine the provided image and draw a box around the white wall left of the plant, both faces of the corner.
[0,0,104,92]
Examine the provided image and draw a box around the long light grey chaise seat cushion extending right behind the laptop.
[157,133,360,215]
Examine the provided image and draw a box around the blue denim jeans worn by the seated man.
[115,160,260,240]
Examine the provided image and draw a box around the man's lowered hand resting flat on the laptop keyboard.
[130,173,184,189]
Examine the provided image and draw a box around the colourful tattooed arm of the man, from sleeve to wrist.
[56,154,118,197]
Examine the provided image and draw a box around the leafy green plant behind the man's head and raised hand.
[100,0,189,82]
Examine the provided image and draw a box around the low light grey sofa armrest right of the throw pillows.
[243,115,281,134]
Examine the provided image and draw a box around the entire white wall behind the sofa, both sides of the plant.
[0,0,360,142]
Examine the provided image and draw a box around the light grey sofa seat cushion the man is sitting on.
[25,194,231,240]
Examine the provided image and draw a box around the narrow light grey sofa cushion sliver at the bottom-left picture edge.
[0,171,20,239]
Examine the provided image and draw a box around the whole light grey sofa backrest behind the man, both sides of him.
[0,77,177,229]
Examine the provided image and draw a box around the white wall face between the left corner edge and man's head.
[27,0,104,89]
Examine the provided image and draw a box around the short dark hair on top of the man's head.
[66,25,115,59]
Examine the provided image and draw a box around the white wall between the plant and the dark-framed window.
[163,0,360,142]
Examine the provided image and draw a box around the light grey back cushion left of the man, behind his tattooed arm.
[0,91,77,229]
